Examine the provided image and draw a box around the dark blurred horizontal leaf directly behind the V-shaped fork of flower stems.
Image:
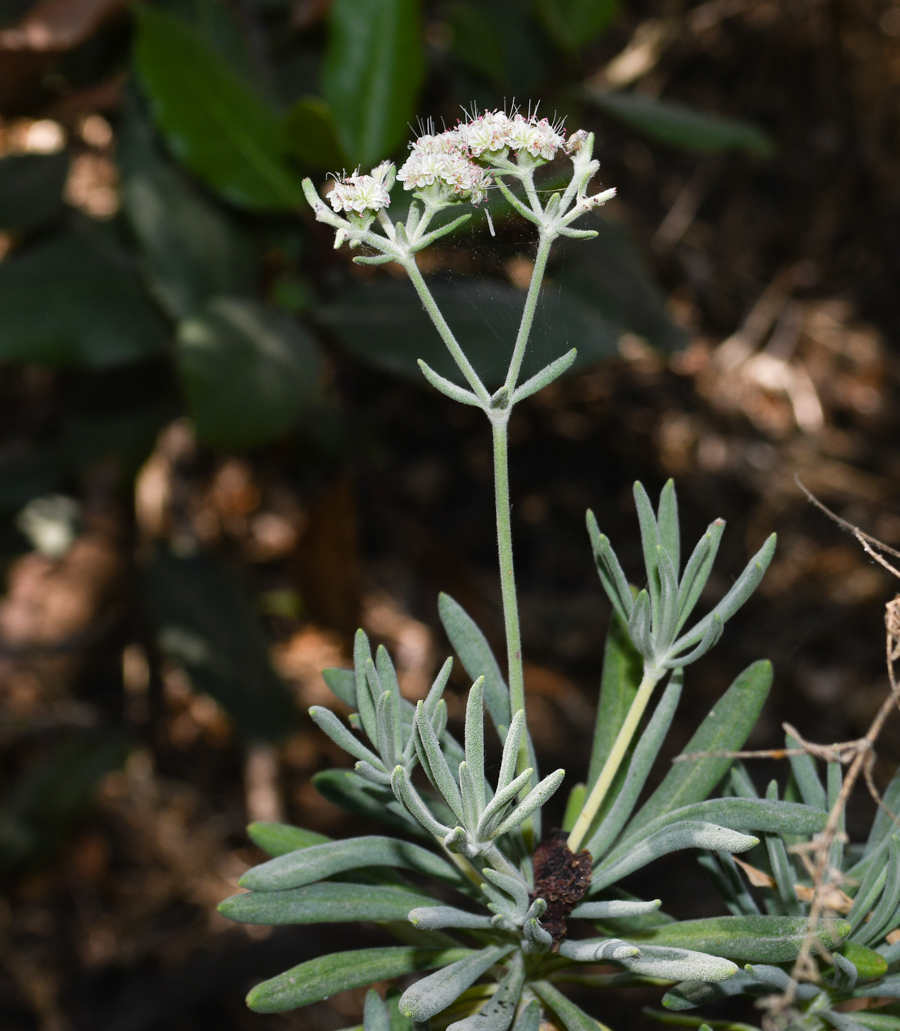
[314,278,621,388]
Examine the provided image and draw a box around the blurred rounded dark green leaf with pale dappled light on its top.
[176,297,321,448]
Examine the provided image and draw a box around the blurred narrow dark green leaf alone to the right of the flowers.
[584,87,774,158]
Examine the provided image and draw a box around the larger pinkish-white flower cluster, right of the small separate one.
[397,111,565,204]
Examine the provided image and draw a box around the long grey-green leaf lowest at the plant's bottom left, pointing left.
[246,945,472,1013]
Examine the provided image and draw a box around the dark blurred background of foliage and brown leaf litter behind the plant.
[0,0,900,1031]
